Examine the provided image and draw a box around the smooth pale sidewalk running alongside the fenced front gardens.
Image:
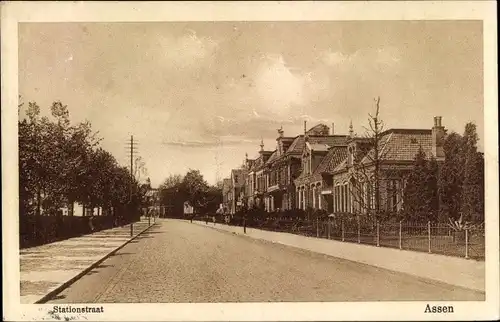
[193,221,486,292]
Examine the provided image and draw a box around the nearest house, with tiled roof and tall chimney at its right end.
[322,117,446,214]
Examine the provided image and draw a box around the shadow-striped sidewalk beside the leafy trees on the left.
[20,218,154,304]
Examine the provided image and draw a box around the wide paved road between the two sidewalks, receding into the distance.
[49,220,484,303]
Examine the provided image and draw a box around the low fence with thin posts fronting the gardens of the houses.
[217,217,485,260]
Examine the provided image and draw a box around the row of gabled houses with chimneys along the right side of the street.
[223,116,446,218]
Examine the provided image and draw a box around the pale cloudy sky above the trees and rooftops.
[19,21,484,186]
